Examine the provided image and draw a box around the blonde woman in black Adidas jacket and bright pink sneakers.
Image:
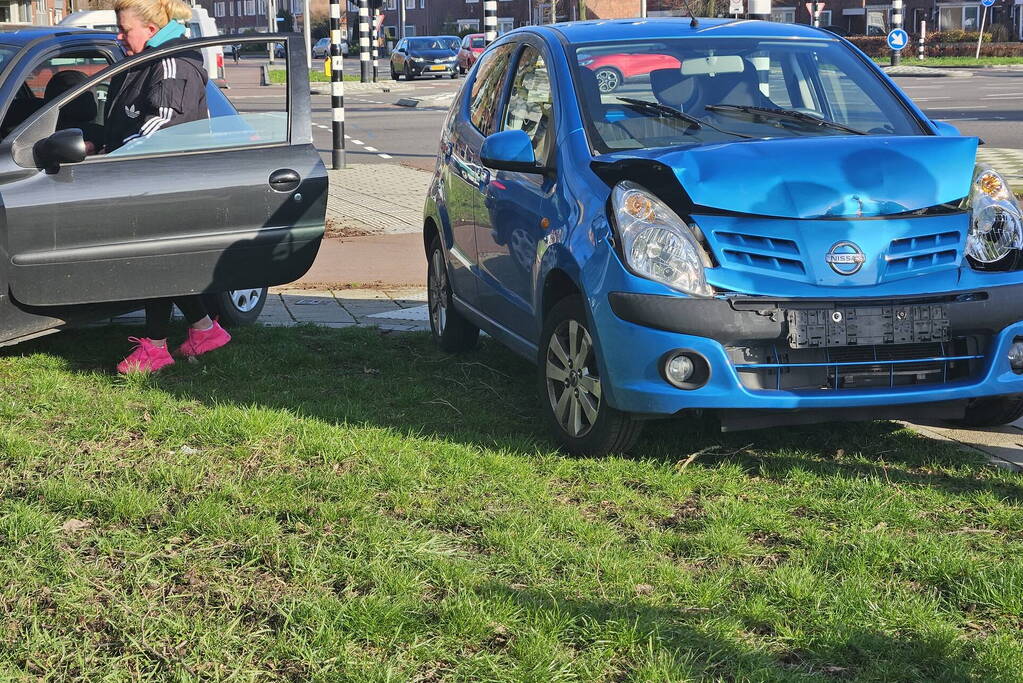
[103,0,231,373]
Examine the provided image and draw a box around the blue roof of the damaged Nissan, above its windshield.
[545,16,836,43]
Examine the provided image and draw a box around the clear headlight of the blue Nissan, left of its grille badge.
[611,180,714,297]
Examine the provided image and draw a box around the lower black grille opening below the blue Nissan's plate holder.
[727,335,987,391]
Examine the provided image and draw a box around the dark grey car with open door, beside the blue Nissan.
[0,27,326,346]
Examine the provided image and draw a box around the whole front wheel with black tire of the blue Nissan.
[537,295,643,456]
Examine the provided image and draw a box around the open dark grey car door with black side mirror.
[0,35,327,306]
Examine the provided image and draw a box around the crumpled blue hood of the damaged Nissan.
[596,135,977,218]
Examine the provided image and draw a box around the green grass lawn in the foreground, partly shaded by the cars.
[0,327,1023,682]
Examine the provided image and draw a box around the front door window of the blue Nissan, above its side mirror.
[502,47,553,164]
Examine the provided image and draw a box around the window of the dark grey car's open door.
[46,43,288,158]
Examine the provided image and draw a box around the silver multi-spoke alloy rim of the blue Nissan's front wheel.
[544,318,601,439]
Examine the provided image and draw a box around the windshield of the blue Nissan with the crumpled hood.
[575,38,923,152]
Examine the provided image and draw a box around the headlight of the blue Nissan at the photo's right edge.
[966,167,1023,270]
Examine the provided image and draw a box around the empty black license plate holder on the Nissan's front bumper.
[786,304,948,349]
